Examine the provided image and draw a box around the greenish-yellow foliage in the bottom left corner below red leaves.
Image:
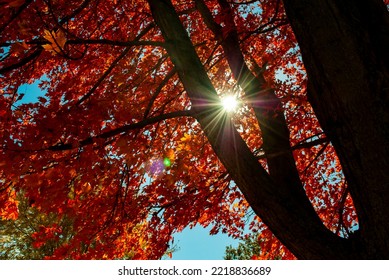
[0,191,149,260]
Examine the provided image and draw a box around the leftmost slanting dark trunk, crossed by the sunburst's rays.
[148,0,355,259]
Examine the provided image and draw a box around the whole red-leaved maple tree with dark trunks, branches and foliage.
[0,0,389,259]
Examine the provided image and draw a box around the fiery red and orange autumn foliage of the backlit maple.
[0,0,386,259]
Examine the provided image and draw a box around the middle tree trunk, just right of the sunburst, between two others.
[195,0,309,215]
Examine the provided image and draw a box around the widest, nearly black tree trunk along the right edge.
[284,0,389,259]
